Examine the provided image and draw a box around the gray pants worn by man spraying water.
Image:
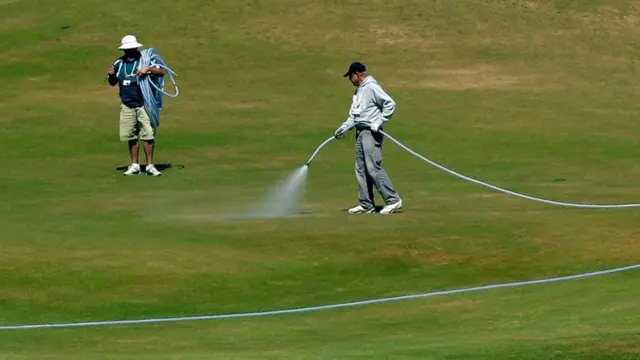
[356,129,399,209]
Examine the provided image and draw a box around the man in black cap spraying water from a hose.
[335,62,403,214]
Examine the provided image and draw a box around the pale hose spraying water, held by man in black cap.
[305,130,640,209]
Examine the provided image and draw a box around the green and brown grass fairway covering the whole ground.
[0,0,640,360]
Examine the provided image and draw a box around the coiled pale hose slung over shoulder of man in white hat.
[138,48,180,128]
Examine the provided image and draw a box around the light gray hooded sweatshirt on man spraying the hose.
[343,75,396,128]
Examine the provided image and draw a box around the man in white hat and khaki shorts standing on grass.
[107,35,164,176]
